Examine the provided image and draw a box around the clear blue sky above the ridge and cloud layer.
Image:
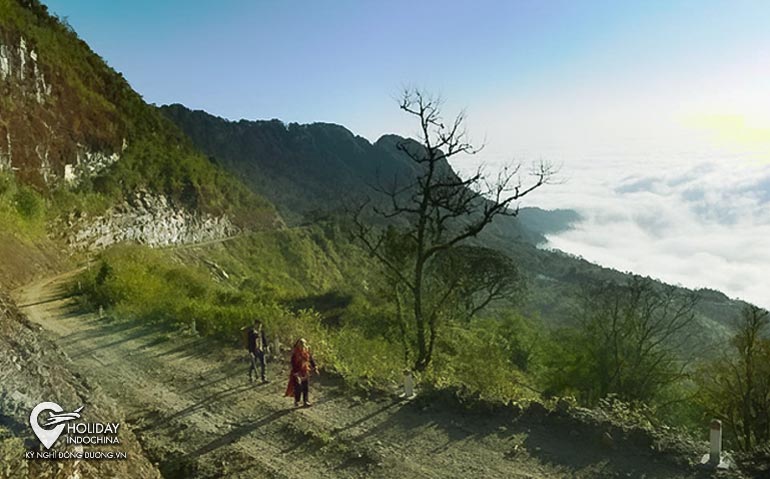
[48,0,770,153]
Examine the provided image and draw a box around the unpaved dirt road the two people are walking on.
[15,273,708,479]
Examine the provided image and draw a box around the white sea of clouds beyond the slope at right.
[522,157,770,308]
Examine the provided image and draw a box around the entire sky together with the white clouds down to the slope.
[47,0,770,307]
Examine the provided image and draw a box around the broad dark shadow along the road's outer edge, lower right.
[337,399,701,479]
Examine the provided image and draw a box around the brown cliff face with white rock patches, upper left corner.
[0,18,126,188]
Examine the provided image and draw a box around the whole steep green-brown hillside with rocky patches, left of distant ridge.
[0,0,280,242]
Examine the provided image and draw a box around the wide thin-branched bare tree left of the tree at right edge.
[549,276,698,404]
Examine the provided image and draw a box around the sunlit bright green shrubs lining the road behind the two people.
[78,245,330,357]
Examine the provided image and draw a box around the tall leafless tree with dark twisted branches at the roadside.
[354,90,554,371]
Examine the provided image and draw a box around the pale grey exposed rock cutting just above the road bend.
[60,191,240,250]
